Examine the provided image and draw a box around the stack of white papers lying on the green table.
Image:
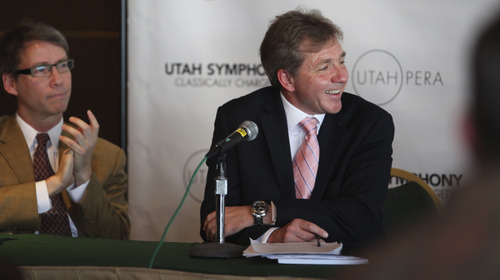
[243,239,368,265]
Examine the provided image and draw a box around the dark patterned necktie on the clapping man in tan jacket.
[33,133,71,236]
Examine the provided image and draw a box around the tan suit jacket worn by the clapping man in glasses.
[0,116,130,239]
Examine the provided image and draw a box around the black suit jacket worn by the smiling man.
[201,87,394,253]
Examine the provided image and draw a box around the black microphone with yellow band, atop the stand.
[205,121,259,158]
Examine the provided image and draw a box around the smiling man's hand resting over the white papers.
[267,219,328,243]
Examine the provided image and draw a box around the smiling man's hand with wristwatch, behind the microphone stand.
[203,206,254,241]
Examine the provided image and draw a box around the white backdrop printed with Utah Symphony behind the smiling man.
[128,0,498,241]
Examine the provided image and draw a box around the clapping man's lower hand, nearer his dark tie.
[45,149,74,197]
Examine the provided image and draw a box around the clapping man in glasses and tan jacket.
[0,21,130,239]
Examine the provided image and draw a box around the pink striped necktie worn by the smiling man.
[293,117,319,199]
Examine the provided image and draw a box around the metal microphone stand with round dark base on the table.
[189,154,245,259]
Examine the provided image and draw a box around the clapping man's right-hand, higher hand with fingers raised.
[59,110,99,186]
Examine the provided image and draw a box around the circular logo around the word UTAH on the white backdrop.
[351,49,404,105]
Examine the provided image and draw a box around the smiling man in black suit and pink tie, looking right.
[201,8,394,254]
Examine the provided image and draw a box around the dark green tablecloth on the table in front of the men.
[0,234,343,278]
